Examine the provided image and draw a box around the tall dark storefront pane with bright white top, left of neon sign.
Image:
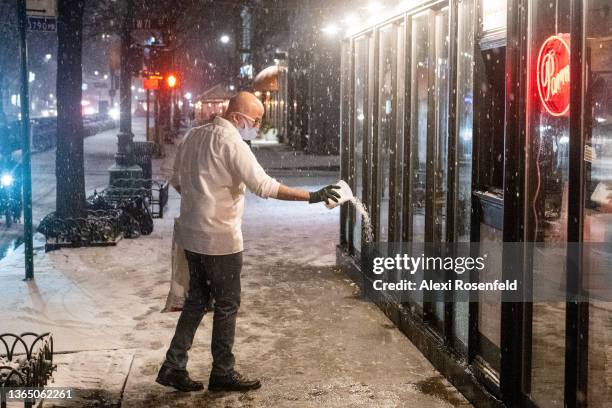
[468,1,506,376]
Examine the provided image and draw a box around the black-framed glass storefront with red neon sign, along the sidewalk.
[338,0,612,407]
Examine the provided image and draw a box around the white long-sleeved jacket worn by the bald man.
[170,117,280,255]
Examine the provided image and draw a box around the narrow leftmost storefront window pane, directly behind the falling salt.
[351,37,368,252]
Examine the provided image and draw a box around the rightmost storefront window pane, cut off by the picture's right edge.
[582,0,612,407]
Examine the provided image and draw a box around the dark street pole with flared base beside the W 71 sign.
[109,0,142,186]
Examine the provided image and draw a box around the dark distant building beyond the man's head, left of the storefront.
[247,0,344,154]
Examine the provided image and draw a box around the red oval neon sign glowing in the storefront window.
[536,35,570,116]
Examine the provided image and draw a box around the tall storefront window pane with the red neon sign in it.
[525,0,570,407]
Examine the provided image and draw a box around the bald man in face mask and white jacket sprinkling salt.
[157,92,339,391]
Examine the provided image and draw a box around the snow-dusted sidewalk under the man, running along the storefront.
[0,134,469,407]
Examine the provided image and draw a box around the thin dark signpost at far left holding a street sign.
[18,0,34,280]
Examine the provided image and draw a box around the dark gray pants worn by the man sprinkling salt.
[164,251,242,376]
